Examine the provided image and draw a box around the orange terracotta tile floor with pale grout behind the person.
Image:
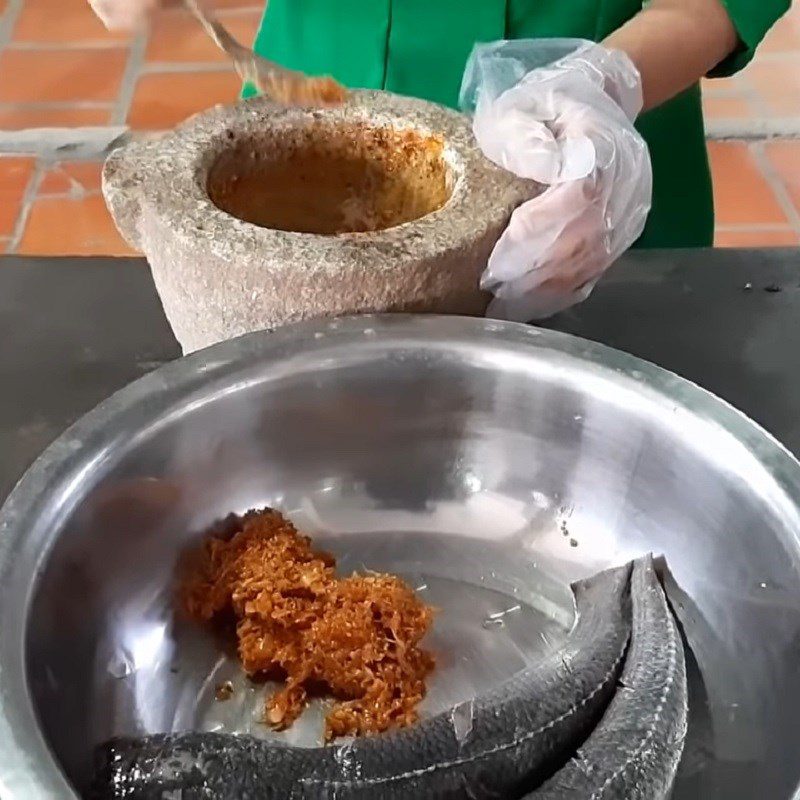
[0,0,800,254]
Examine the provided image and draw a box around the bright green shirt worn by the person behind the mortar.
[244,0,789,247]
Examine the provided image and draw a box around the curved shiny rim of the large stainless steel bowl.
[0,314,800,800]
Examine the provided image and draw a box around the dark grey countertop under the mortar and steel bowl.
[0,249,800,498]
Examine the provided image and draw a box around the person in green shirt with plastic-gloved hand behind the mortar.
[90,0,790,319]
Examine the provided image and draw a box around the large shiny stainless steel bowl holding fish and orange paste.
[0,317,800,800]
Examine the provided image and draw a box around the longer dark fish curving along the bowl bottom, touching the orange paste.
[92,564,632,800]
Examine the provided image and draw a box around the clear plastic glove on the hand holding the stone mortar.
[461,39,653,322]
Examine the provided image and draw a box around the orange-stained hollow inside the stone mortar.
[207,120,452,234]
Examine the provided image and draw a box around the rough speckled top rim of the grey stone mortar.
[123,91,531,270]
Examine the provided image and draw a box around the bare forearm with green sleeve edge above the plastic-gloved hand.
[603,0,789,111]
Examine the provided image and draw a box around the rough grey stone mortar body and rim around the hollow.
[103,92,539,352]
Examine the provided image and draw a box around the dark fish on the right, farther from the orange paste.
[528,556,688,800]
